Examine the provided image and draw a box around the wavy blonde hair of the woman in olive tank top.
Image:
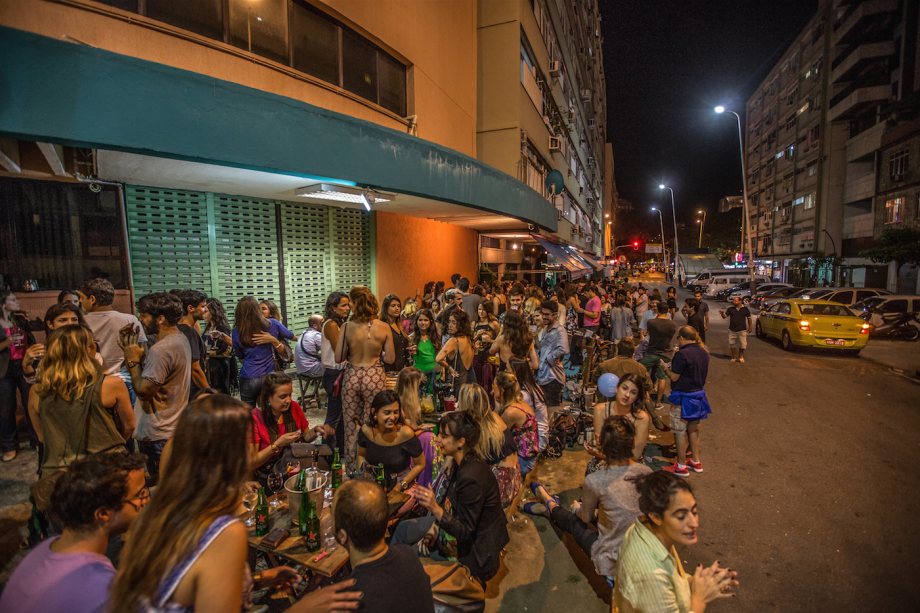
[35,324,101,402]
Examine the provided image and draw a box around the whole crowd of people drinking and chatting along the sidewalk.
[0,275,737,613]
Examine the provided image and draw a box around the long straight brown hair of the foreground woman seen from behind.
[109,394,252,613]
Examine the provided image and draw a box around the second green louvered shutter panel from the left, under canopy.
[208,194,281,324]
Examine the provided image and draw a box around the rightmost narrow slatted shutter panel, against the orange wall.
[329,209,372,298]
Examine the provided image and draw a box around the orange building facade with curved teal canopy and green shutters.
[0,0,588,327]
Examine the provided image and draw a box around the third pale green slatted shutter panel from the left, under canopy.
[279,202,331,335]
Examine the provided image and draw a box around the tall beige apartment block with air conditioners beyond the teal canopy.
[476,0,610,274]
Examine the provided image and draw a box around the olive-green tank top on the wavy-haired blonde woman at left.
[38,375,125,471]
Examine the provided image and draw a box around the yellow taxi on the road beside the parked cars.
[755,300,870,355]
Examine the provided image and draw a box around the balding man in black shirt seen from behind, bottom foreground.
[332,479,434,613]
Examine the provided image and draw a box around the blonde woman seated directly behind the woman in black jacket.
[457,383,521,508]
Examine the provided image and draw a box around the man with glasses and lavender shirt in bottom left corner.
[0,453,150,613]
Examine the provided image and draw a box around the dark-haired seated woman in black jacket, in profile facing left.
[391,411,509,584]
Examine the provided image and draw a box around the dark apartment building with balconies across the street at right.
[745,0,920,287]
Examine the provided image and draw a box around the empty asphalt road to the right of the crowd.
[631,275,920,613]
